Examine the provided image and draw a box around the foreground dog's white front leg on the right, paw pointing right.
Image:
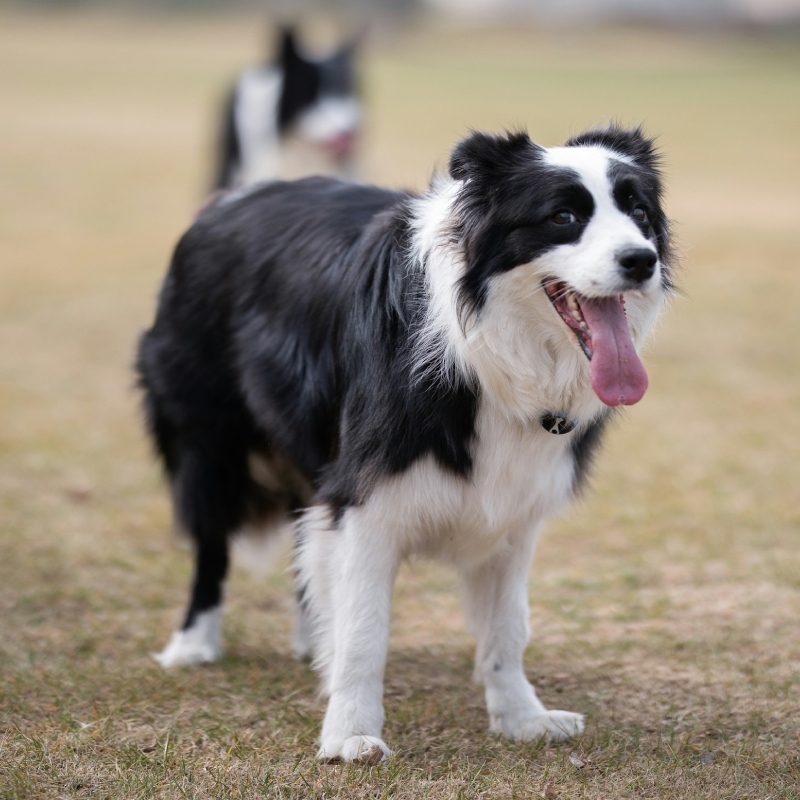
[459,529,583,741]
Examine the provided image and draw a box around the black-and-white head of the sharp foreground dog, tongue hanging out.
[450,126,672,406]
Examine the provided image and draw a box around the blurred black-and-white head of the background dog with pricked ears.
[278,28,361,160]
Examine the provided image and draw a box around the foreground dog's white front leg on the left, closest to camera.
[317,504,398,763]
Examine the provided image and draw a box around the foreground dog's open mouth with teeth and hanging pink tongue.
[542,277,648,406]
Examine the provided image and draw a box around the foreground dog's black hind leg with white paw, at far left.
[154,427,248,667]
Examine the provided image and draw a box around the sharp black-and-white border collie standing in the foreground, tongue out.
[138,126,672,763]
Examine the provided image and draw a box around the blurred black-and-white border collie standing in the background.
[215,28,361,189]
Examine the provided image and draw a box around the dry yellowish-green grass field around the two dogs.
[0,7,800,800]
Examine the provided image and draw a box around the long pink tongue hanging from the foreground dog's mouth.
[580,297,647,406]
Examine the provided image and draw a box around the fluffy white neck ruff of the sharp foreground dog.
[411,177,603,424]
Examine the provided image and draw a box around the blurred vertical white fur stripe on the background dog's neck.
[234,69,282,184]
